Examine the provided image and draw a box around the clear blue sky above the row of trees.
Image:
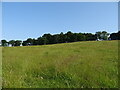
[2,2,118,40]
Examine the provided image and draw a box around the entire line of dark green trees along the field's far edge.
[1,31,120,46]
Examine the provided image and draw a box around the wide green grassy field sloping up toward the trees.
[2,41,118,88]
